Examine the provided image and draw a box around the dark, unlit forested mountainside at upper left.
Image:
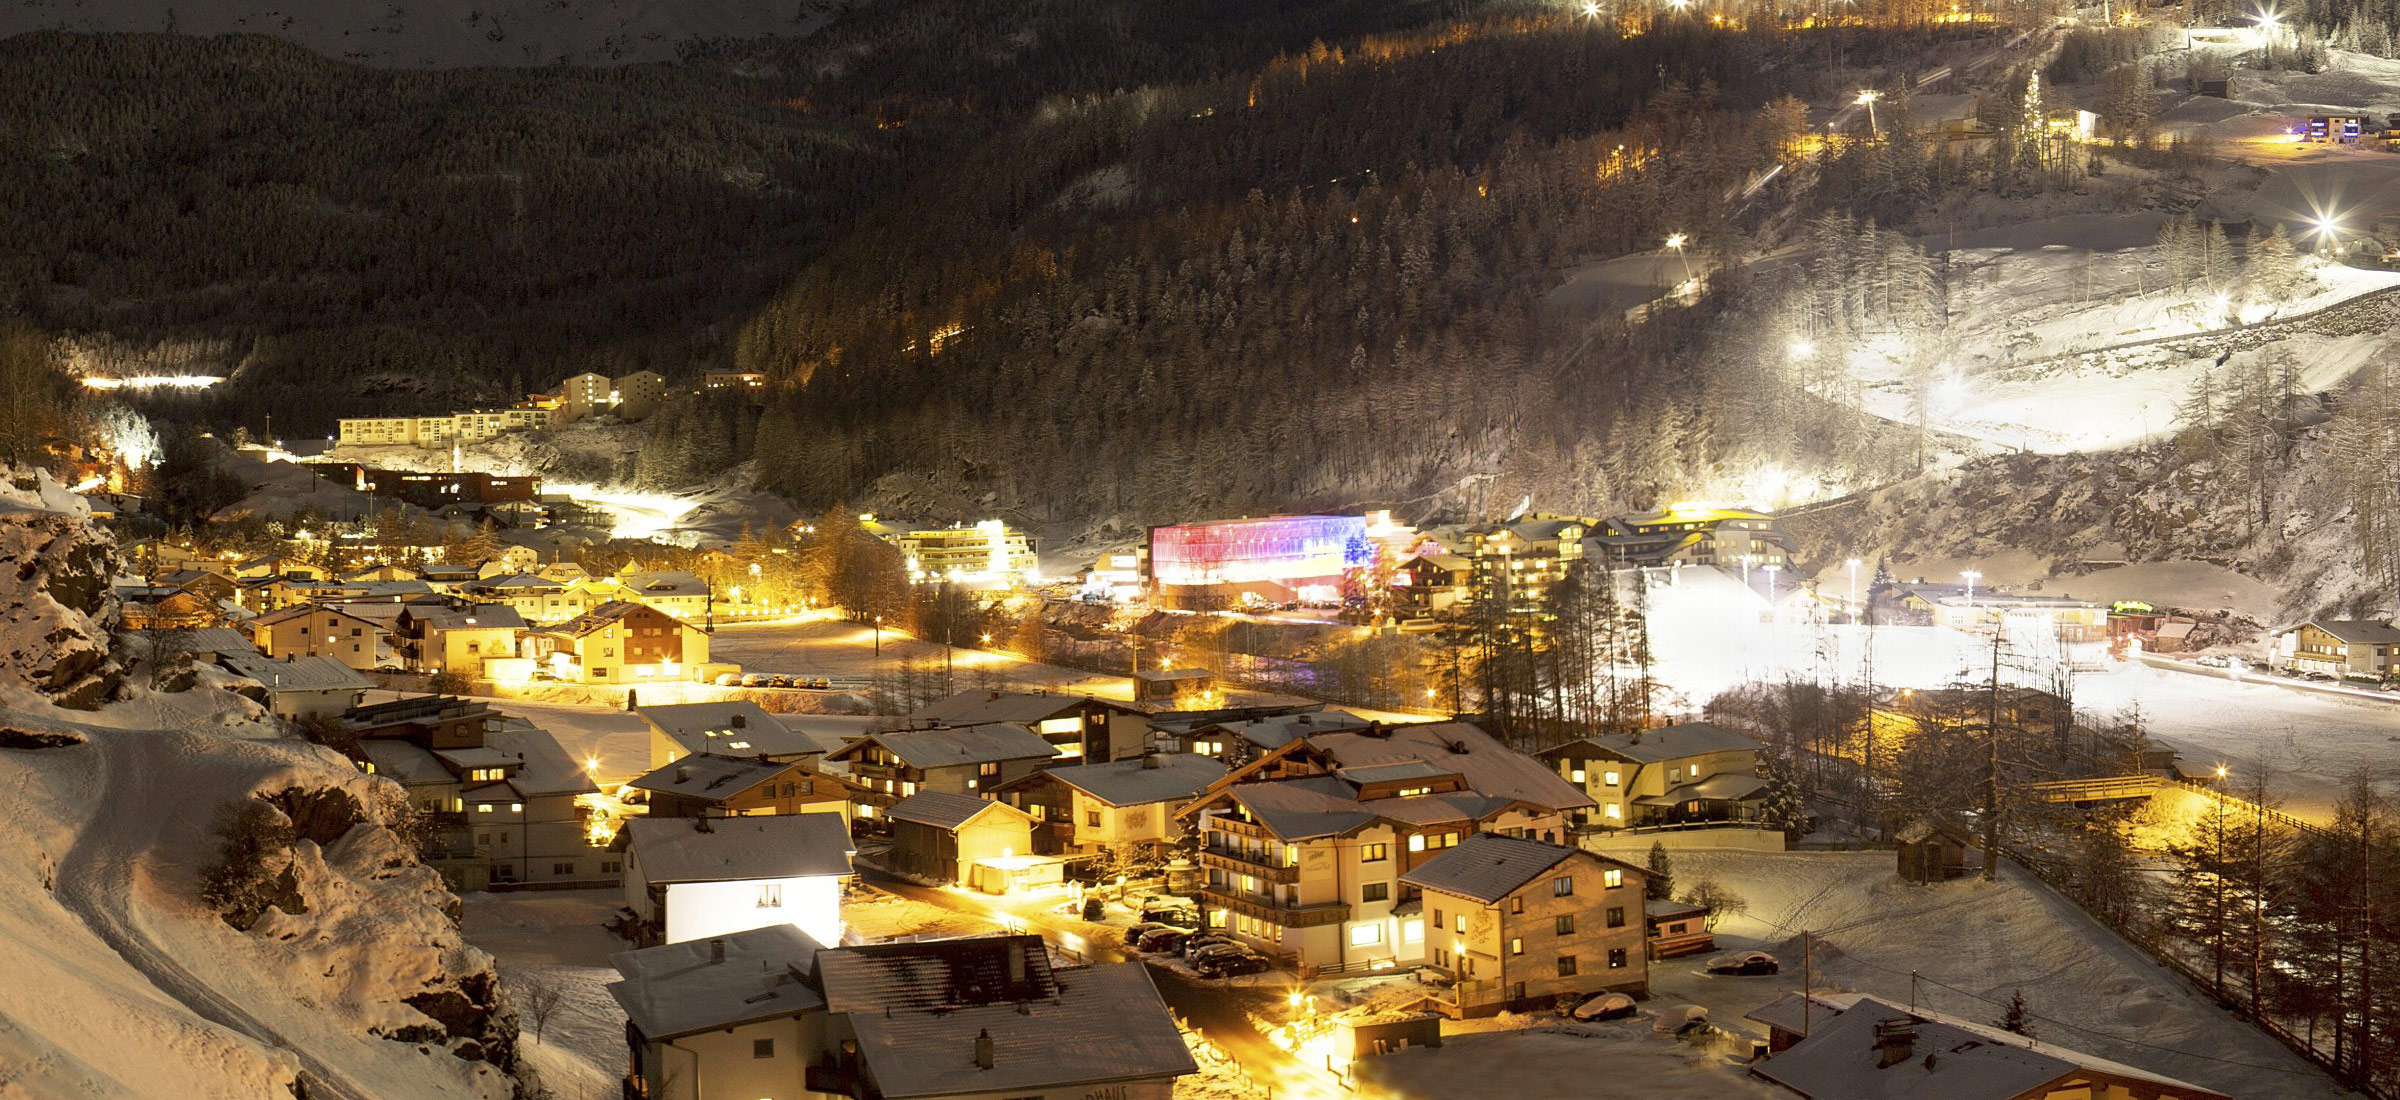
[0,0,1423,432]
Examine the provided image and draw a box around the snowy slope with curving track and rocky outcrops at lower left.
[0,465,538,1100]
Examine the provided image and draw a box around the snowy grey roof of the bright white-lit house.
[624,814,852,884]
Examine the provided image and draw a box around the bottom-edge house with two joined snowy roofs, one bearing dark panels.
[610,925,1198,1100]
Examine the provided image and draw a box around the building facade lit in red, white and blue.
[1142,516,1375,608]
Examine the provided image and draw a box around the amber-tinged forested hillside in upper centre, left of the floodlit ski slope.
[724,12,1987,519]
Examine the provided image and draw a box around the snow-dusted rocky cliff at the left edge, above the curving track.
[0,468,118,711]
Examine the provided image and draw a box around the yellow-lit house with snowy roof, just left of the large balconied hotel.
[998,752,1226,855]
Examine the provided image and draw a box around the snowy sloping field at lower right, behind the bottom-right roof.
[1651,850,2347,1100]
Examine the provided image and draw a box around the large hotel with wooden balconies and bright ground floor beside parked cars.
[1178,723,1591,970]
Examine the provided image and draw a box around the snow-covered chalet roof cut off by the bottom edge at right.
[1742,992,2230,1100]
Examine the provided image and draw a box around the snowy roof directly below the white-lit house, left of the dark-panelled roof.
[607,925,826,1042]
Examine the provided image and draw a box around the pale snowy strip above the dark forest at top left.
[0,0,847,70]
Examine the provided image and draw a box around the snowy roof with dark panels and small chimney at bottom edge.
[816,937,1198,1100]
